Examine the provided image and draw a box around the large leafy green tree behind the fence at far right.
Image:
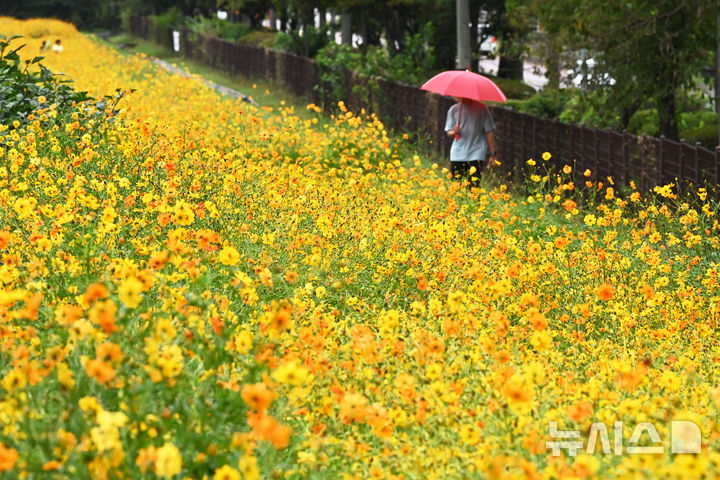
[576,0,716,139]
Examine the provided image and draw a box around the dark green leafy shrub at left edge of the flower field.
[0,37,123,128]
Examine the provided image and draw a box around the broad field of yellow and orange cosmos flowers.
[0,18,720,479]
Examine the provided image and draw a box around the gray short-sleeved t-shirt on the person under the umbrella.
[445,102,495,162]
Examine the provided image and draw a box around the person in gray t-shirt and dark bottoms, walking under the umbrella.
[445,97,497,187]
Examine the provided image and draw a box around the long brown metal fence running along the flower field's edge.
[130,17,720,191]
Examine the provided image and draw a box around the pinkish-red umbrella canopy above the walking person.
[420,70,507,102]
